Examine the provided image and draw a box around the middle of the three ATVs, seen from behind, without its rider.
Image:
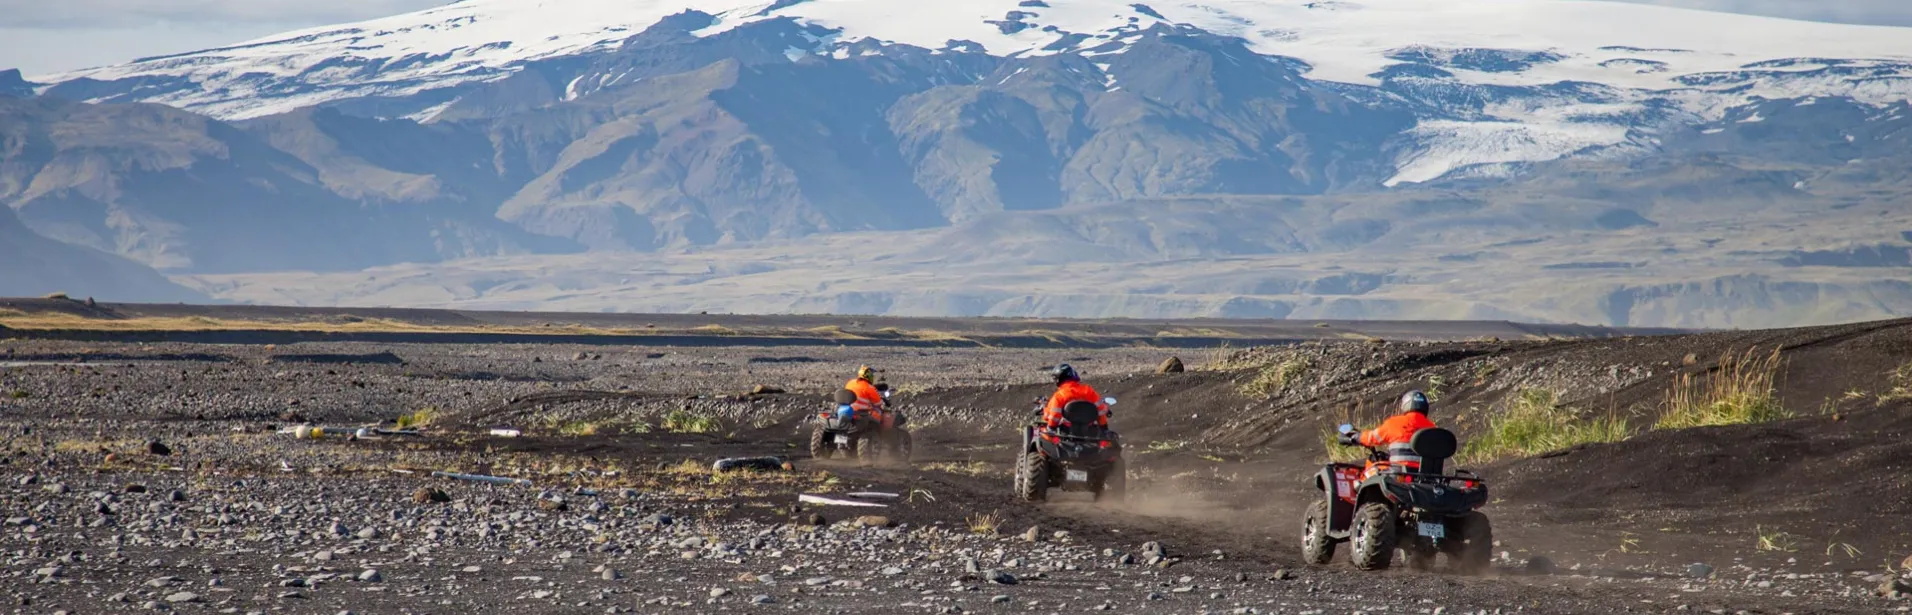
[1015,397,1128,502]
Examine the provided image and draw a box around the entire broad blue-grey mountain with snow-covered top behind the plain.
[11,0,1912,327]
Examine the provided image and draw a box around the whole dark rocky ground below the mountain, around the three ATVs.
[0,321,1912,613]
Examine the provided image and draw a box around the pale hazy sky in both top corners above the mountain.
[0,0,1912,76]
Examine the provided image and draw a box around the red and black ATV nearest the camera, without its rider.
[1302,424,1493,575]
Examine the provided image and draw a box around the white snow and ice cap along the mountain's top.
[36,0,1912,185]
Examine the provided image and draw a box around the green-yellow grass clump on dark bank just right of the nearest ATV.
[1457,390,1633,464]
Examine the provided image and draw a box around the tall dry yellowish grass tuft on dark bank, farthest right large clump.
[1654,348,1793,430]
